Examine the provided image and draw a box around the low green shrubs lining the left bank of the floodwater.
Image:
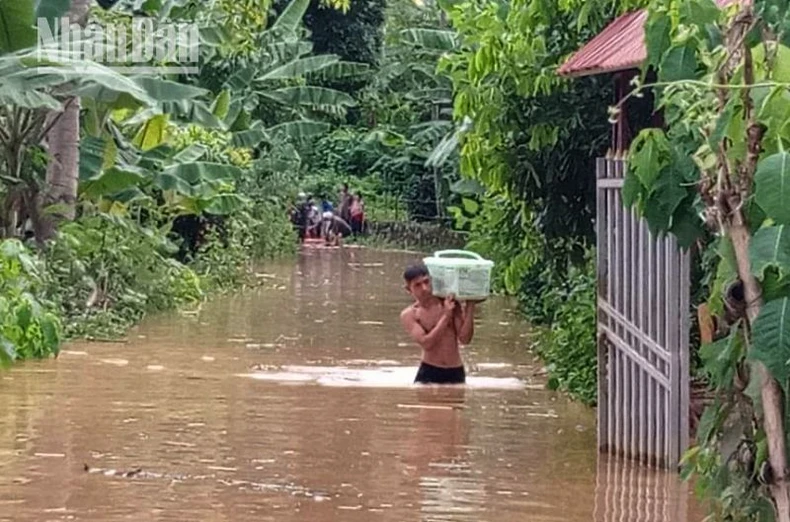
[0,201,295,364]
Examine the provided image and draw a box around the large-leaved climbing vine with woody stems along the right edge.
[624,0,790,521]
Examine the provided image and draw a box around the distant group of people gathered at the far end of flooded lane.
[291,183,365,246]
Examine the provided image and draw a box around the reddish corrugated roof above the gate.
[557,0,748,77]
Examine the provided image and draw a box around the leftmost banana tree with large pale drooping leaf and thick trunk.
[0,0,241,241]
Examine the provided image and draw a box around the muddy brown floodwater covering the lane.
[0,248,702,522]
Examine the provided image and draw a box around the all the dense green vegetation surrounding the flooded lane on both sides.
[0,0,790,520]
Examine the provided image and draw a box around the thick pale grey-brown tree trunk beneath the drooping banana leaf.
[36,0,92,241]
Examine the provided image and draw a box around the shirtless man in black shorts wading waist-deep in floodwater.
[400,264,475,384]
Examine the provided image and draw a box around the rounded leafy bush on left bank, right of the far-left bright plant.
[44,214,203,338]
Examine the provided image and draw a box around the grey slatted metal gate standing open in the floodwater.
[596,154,690,467]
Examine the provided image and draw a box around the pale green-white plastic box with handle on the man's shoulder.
[423,250,494,301]
